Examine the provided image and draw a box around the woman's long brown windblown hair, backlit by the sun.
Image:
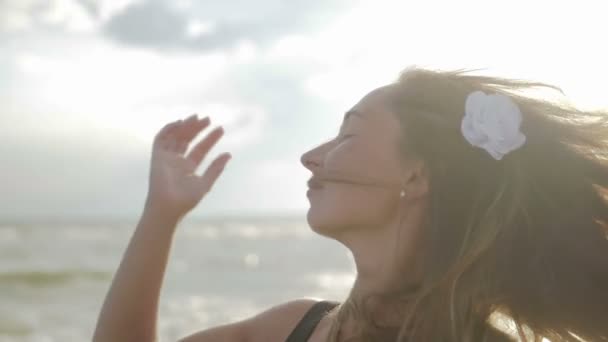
[329,67,608,342]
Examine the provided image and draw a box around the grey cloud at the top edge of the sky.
[104,0,354,51]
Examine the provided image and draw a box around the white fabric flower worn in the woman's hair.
[461,91,526,160]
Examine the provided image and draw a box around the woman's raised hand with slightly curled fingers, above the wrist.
[145,115,231,220]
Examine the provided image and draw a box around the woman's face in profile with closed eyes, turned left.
[301,86,405,237]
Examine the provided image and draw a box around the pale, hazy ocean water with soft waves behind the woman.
[0,217,354,342]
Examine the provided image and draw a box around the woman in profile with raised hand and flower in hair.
[95,68,608,342]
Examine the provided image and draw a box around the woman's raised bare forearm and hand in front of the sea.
[93,115,230,342]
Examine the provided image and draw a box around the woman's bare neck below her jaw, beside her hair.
[343,206,425,333]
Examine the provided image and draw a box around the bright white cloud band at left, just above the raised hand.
[0,35,264,143]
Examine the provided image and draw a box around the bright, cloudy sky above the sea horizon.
[0,0,608,221]
